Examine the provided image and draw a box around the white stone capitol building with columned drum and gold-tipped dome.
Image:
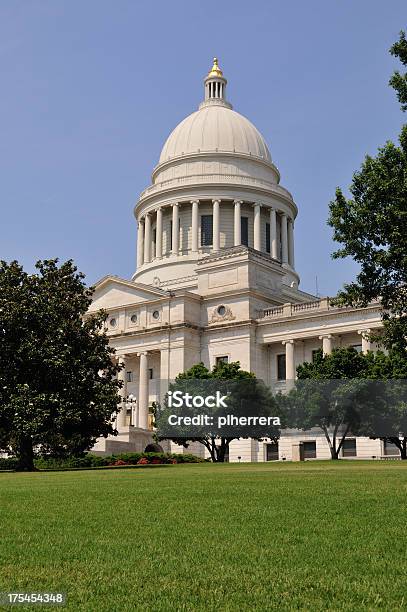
[91,59,391,461]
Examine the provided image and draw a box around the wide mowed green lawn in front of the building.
[0,461,407,612]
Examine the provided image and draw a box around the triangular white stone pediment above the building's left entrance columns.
[89,276,167,311]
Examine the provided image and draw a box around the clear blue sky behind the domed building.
[0,0,407,295]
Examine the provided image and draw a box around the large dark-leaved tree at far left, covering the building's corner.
[0,259,121,470]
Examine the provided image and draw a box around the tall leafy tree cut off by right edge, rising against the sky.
[328,32,407,353]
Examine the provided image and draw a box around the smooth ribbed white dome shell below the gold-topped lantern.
[159,104,271,164]
